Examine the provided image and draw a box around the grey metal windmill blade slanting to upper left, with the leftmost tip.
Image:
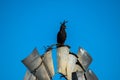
[22,49,50,80]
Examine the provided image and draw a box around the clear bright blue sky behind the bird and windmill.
[0,0,120,80]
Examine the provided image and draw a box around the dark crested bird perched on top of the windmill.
[57,21,67,45]
